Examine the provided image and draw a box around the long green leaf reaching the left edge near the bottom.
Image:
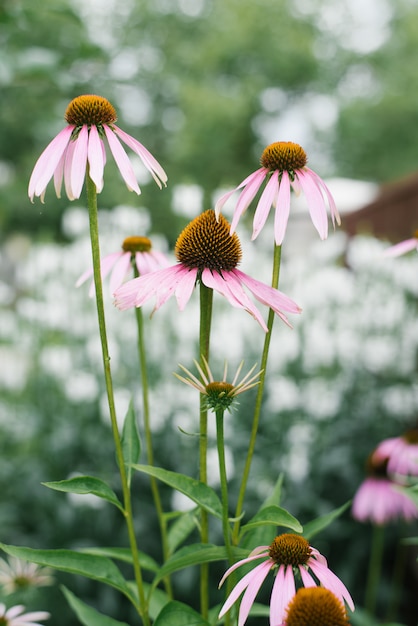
[0,543,137,606]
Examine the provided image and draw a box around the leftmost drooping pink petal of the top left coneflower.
[28,126,75,202]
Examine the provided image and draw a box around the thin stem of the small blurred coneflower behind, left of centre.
[134,292,173,598]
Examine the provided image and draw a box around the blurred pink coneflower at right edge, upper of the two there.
[373,428,418,479]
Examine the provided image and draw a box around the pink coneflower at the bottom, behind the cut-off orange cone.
[219,533,354,626]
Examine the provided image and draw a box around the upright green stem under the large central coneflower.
[199,282,213,619]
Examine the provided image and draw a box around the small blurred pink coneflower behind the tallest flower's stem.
[76,237,168,297]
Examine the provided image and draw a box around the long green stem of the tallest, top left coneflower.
[86,172,150,626]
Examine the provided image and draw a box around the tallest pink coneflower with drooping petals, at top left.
[28,95,167,202]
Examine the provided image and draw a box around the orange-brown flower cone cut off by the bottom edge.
[285,587,349,626]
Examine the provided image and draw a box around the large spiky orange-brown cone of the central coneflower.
[175,209,242,272]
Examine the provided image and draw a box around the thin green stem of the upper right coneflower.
[232,244,282,545]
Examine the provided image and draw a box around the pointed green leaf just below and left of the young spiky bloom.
[132,465,222,519]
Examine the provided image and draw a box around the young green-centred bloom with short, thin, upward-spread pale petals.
[174,357,261,411]
